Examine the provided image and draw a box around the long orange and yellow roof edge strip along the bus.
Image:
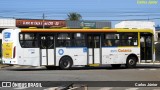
[21,28,153,33]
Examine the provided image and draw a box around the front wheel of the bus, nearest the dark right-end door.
[126,56,137,68]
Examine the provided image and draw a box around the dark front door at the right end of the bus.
[140,33,153,62]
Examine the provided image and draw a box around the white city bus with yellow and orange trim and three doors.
[2,28,155,69]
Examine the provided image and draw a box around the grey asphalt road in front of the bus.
[0,65,160,90]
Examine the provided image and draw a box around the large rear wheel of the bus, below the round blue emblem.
[59,56,73,70]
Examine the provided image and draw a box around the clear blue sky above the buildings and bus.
[0,0,160,25]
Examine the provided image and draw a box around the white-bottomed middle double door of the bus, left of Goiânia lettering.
[87,34,100,65]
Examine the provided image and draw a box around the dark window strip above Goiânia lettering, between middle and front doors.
[102,33,138,46]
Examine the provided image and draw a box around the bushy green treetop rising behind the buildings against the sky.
[67,12,82,21]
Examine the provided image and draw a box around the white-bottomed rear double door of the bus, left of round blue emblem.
[39,34,54,65]
